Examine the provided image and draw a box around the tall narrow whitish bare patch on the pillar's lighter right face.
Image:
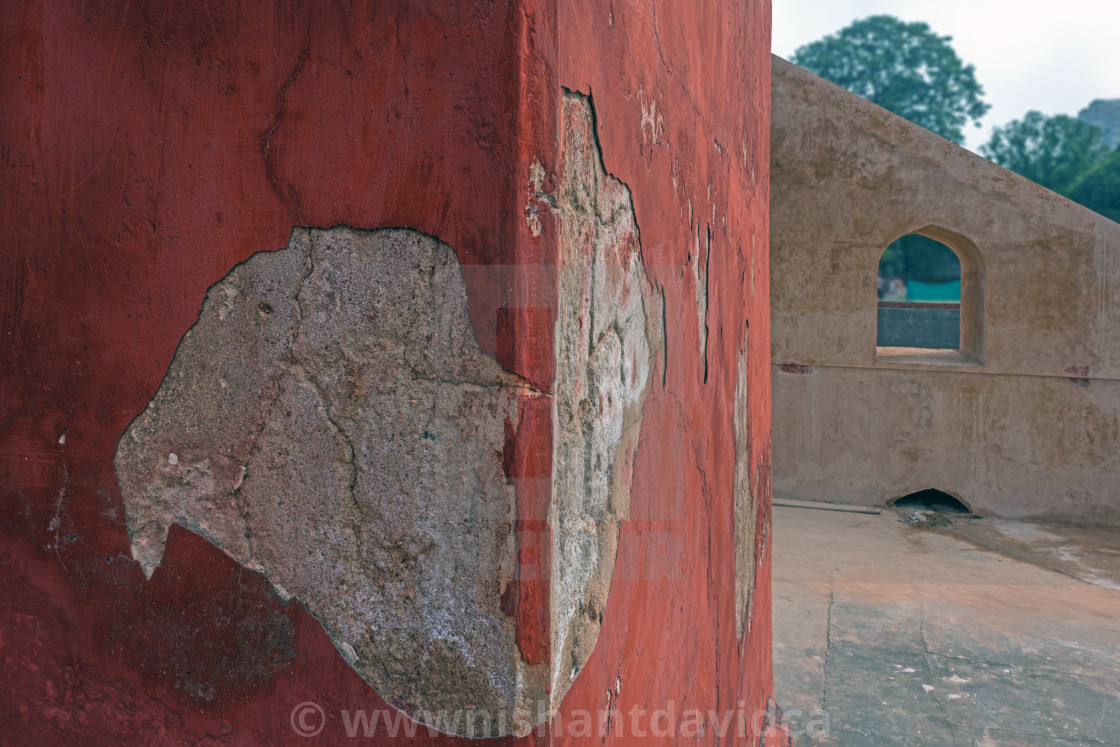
[549,92,660,704]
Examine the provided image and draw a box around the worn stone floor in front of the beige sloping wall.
[774,507,1120,747]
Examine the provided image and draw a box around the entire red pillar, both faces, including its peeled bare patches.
[0,0,775,744]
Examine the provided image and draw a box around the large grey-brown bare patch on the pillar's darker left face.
[116,227,533,736]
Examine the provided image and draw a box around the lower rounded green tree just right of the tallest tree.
[980,111,1109,195]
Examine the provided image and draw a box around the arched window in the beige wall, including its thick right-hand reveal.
[876,226,984,363]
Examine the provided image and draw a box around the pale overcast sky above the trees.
[773,0,1120,150]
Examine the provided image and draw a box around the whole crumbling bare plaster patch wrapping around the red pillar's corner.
[115,93,660,737]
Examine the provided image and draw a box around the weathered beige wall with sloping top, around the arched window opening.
[772,58,1120,524]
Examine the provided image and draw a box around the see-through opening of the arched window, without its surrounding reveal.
[876,234,961,351]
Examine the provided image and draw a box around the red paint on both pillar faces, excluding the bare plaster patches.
[0,0,771,744]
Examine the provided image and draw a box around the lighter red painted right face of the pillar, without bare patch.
[559,0,771,741]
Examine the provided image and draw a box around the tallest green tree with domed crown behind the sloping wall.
[792,16,990,144]
